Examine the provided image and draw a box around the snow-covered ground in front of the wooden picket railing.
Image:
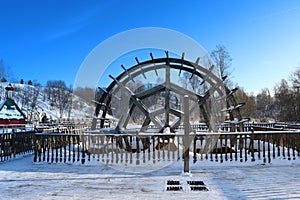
[0,155,300,200]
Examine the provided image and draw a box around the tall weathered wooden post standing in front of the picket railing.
[183,95,190,173]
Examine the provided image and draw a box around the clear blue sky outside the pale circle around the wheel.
[0,0,300,92]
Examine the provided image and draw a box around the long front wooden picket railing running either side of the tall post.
[34,131,300,165]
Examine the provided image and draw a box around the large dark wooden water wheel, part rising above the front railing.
[92,52,243,151]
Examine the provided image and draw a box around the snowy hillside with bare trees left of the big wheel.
[0,83,94,120]
